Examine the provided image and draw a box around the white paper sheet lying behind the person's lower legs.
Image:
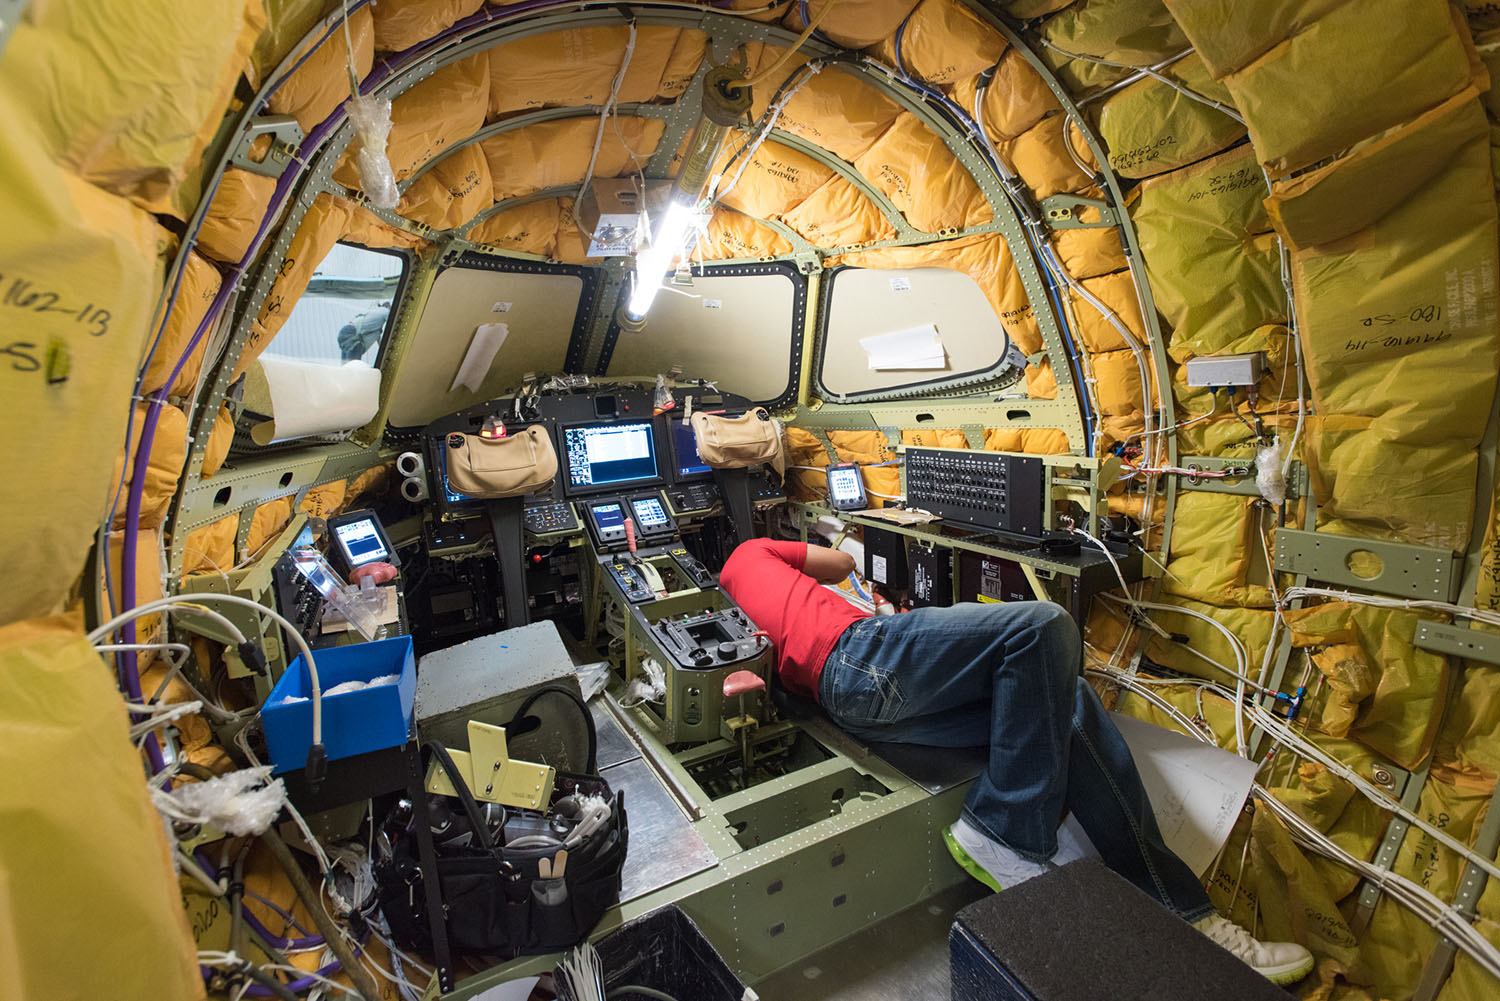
[1110,713,1256,876]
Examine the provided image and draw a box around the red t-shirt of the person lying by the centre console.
[719,539,867,699]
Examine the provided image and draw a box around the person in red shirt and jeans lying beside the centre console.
[719,539,1313,983]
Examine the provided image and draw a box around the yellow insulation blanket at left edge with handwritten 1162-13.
[0,96,164,621]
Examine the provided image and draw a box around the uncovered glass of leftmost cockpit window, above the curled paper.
[266,243,407,366]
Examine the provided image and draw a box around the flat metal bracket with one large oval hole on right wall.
[1277,528,1461,602]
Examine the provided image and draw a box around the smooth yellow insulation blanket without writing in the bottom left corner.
[0,618,203,1001]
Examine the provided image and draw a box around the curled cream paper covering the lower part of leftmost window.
[245,354,380,444]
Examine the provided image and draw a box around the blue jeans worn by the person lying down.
[819,602,1214,921]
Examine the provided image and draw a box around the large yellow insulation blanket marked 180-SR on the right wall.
[1292,132,1500,551]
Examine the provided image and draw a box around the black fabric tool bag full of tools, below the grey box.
[375,689,629,956]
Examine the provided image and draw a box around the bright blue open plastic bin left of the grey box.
[261,636,417,774]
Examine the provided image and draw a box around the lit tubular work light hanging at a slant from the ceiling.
[618,66,750,332]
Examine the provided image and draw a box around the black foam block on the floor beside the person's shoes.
[948,861,1290,1001]
